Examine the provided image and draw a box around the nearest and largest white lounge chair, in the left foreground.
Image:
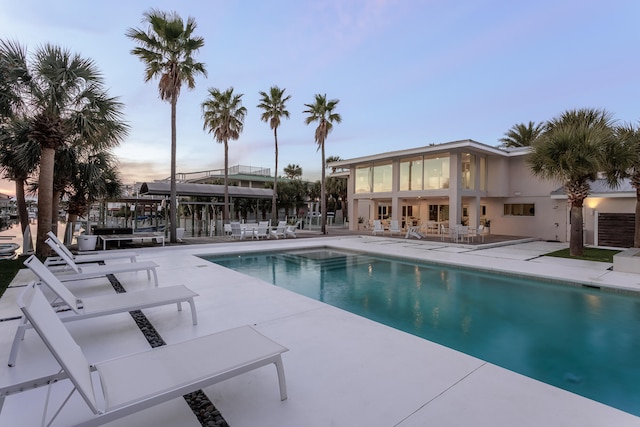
[0,287,288,426]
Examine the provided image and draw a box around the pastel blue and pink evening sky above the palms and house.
[0,0,640,193]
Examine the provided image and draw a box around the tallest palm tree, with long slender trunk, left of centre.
[126,9,207,243]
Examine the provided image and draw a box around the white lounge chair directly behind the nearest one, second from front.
[9,274,198,366]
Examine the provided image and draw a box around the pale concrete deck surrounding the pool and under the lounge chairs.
[0,235,640,427]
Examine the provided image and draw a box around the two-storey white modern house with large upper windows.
[328,140,636,247]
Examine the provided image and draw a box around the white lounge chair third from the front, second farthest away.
[42,239,158,287]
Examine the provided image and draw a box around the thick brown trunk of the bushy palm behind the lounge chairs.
[36,147,56,258]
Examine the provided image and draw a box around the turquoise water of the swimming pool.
[203,249,640,416]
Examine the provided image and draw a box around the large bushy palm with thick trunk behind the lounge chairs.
[1,44,128,256]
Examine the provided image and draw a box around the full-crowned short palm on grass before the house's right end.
[527,109,615,256]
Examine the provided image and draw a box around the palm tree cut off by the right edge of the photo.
[605,123,640,248]
